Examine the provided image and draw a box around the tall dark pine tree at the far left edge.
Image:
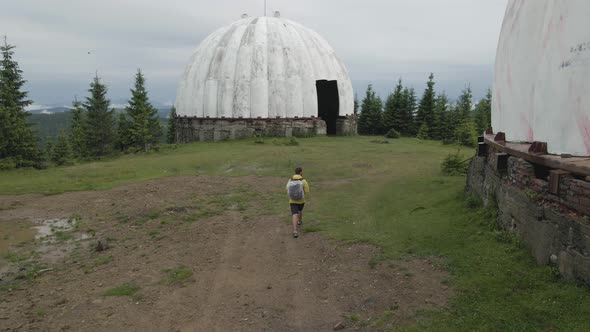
[0,37,42,167]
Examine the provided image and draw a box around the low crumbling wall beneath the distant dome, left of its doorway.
[176,117,326,143]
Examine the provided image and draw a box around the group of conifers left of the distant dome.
[0,38,173,169]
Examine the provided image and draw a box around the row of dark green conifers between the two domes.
[355,74,492,147]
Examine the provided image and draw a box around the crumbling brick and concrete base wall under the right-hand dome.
[466,149,590,285]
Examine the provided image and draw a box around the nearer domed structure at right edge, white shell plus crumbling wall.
[467,0,590,285]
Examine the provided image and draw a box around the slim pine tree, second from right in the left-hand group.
[84,75,115,158]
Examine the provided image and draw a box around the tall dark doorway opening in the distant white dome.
[315,80,340,135]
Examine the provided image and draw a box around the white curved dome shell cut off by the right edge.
[492,0,590,156]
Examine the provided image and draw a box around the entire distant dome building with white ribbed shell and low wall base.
[175,12,356,142]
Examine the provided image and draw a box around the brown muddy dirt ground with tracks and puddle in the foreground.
[0,176,452,331]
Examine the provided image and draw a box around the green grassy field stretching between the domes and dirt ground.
[0,137,590,331]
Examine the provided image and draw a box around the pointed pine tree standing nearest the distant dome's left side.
[125,69,162,151]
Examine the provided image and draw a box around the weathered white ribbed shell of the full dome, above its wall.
[175,17,354,118]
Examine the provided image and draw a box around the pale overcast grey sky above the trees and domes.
[0,0,508,105]
